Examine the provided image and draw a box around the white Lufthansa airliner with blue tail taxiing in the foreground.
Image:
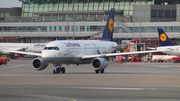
[3,8,166,74]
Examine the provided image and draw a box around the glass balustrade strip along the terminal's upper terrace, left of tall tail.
[5,14,108,22]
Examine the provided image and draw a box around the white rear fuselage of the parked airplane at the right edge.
[156,46,180,56]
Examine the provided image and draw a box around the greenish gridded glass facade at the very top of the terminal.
[21,0,154,17]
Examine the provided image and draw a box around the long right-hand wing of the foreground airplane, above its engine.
[81,49,170,59]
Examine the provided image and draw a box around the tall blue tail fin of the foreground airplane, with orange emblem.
[100,8,115,41]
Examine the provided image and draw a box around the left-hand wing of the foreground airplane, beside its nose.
[2,50,41,56]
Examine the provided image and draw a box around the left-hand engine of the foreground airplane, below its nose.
[32,57,49,70]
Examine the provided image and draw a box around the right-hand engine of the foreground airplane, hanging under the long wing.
[91,58,109,71]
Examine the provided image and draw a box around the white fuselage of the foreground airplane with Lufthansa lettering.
[42,40,117,64]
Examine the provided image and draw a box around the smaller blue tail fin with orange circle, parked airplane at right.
[157,27,174,46]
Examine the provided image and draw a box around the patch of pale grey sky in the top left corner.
[0,0,22,8]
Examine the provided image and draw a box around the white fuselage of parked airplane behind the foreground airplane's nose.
[0,43,47,54]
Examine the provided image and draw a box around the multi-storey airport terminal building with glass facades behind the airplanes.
[0,0,180,46]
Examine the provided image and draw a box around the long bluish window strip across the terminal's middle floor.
[0,26,180,33]
